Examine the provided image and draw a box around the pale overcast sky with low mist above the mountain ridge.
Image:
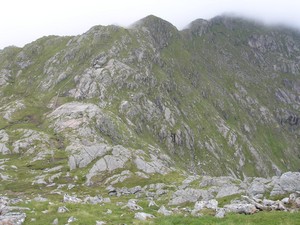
[0,0,300,49]
